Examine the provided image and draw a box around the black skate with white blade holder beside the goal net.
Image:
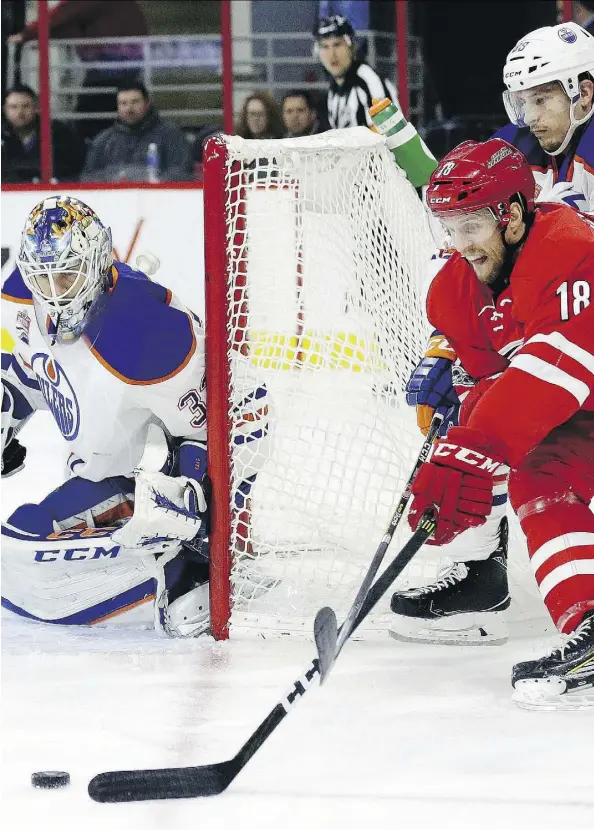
[390,518,510,645]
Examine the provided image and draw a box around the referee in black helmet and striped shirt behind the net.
[314,15,398,130]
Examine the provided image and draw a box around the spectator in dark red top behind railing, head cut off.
[8,0,148,138]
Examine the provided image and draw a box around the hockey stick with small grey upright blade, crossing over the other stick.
[314,412,444,683]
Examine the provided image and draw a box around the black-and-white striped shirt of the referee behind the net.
[328,61,398,130]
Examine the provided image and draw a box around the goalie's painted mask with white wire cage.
[17,196,113,343]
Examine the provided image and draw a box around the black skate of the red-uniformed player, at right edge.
[512,611,594,709]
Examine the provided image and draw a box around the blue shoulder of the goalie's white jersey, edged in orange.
[84,262,196,385]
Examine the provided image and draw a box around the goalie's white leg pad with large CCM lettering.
[2,479,158,625]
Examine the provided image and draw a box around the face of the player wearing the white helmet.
[513,82,570,153]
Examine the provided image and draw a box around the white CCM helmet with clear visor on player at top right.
[503,23,594,156]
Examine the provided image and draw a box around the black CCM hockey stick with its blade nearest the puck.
[89,510,437,802]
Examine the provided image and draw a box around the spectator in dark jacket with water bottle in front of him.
[81,82,192,181]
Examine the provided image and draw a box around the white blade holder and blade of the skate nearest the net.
[388,612,508,646]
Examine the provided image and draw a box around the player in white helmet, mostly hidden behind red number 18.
[388,23,594,645]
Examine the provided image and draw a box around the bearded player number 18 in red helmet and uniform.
[400,138,594,706]
